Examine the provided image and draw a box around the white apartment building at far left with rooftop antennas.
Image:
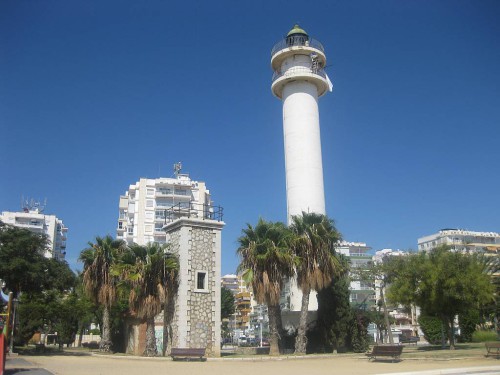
[0,201,68,260]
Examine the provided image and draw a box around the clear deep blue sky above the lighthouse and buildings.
[0,0,500,274]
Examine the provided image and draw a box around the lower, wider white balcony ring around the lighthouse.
[271,66,332,99]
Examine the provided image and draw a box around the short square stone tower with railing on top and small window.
[164,207,225,357]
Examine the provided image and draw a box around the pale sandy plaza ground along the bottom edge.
[6,354,500,375]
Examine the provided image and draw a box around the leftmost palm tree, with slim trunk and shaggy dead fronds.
[79,235,125,351]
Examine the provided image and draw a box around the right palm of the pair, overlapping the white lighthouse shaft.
[290,212,342,354]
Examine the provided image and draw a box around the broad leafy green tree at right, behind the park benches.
[389,245,494,349]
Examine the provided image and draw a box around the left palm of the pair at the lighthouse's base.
[237,219,295,355]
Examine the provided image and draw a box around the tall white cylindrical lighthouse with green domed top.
[271,25,332,224]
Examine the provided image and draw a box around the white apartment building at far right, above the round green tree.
[418,229,500,254]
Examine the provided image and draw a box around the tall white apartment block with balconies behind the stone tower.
[116,173,213,245]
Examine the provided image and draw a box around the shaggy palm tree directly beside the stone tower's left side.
[113,242,179,357]
